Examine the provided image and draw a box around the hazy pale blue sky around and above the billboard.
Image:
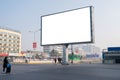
[0,0,120,50]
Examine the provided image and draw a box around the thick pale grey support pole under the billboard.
[62,44,68,65]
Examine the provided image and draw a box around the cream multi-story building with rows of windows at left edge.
[0,27,21,53]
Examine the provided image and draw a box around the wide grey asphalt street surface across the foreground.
[0,63,120,80]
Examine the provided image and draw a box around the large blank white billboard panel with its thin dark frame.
[41,6,93,45]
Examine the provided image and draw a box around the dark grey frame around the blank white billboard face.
[40,6,94,46]
